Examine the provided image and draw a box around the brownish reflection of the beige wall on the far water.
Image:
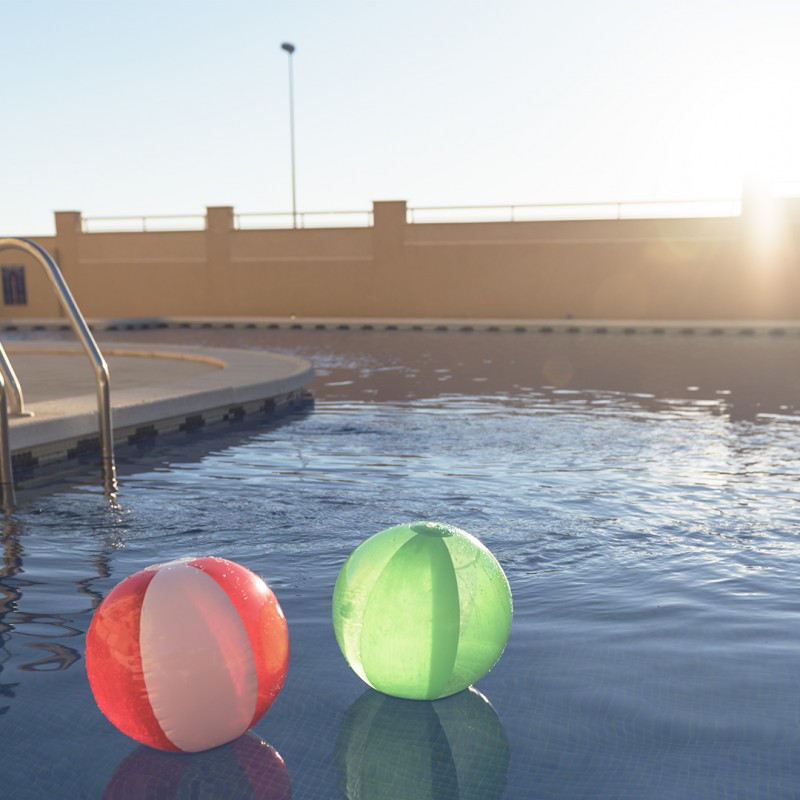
[79,329,800,420]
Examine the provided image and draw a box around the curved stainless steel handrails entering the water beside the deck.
[0,238,117,504]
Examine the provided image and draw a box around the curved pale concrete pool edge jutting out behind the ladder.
[7,341,313,477]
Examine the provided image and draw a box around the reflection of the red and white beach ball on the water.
[103,732,292,800]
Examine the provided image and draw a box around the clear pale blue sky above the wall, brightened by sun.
[0,0,800,235]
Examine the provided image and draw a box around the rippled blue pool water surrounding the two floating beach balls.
[0,330,800,800]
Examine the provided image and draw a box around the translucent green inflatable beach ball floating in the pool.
[333,522,512,700]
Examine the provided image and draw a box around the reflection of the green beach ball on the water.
[336,688,510,800]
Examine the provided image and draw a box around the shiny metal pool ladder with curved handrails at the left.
[0,238,117,511]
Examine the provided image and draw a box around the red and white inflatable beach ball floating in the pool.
[86,558,289,752]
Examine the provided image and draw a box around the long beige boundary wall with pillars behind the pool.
[0,200,800,320]
